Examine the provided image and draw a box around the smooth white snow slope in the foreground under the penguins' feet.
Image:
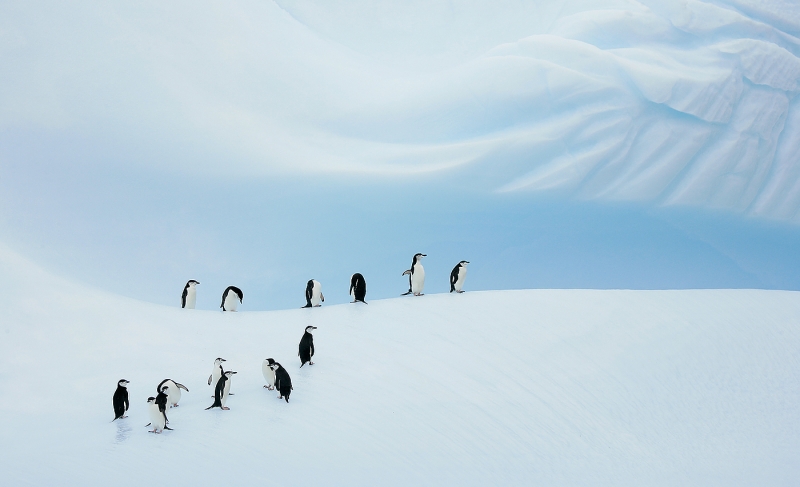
[0,244,800,486]
